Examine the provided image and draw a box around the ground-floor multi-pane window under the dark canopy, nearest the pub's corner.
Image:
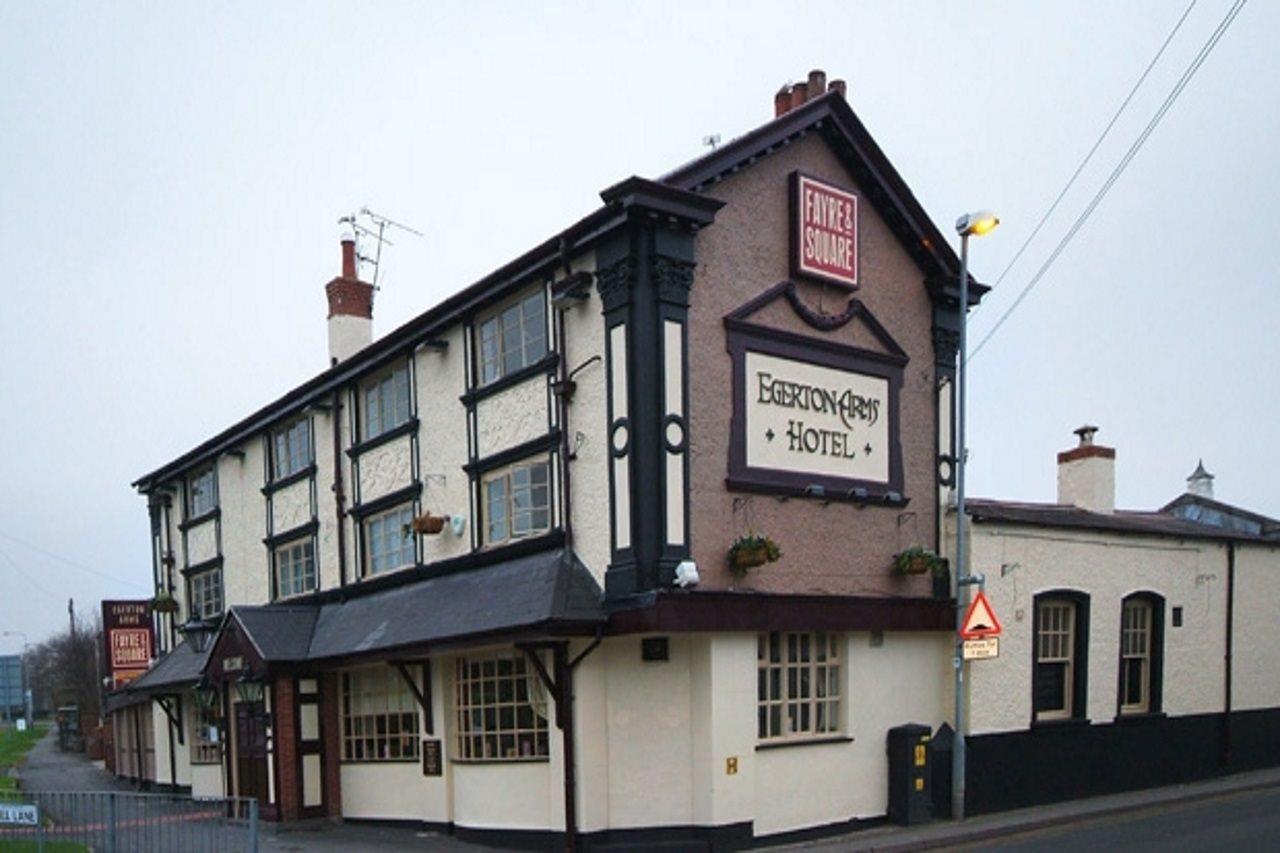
[456,654,550,761]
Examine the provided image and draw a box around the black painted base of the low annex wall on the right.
[957,708,1280,815]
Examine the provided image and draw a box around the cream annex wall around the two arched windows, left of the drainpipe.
[962,515,1226,734]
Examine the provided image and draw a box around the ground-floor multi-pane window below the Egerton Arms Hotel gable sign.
[755,631,842,740]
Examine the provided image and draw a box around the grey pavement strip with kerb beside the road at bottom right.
[781,772,1280,853]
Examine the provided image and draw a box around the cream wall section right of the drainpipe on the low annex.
[1228,544,1280,711]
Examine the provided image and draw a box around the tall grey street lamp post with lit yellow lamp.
[951,210,1000,821]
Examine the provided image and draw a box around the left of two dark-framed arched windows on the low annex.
[1032,589,1089,722]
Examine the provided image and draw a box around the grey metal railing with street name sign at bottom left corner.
[0,792,257,853]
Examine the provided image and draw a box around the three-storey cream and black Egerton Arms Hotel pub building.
[111,72,1280,849]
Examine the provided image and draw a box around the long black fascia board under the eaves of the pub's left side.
[132,205,627,494]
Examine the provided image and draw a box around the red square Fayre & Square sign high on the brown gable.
[791,172,858,291]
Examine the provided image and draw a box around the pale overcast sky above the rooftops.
[0,0,1280,651]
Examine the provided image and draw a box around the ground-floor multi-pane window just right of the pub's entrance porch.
[342,666,419,761]
